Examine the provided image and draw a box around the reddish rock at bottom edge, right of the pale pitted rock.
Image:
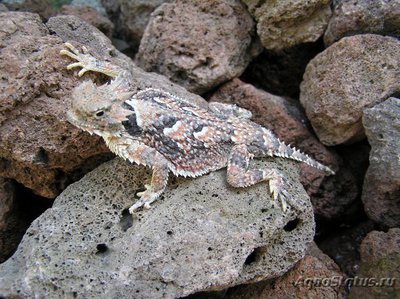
[223,243,346,299]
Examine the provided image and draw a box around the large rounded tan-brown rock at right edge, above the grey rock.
[300,34,400,145]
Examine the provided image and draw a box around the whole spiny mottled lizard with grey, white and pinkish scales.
[61,43,333,213]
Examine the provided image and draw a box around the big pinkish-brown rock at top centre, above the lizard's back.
[136,0,261,94]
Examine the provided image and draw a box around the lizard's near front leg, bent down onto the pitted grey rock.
[105,137,169,214]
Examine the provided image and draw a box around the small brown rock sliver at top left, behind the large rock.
[58,5,114,38]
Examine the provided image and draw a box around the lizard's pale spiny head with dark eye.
[67,81,134,135]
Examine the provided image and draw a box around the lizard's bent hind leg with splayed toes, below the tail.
[227,144,291,211]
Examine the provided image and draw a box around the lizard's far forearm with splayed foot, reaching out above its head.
[60,43,127,78]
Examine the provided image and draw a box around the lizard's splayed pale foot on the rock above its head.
[60,43,98,77]
